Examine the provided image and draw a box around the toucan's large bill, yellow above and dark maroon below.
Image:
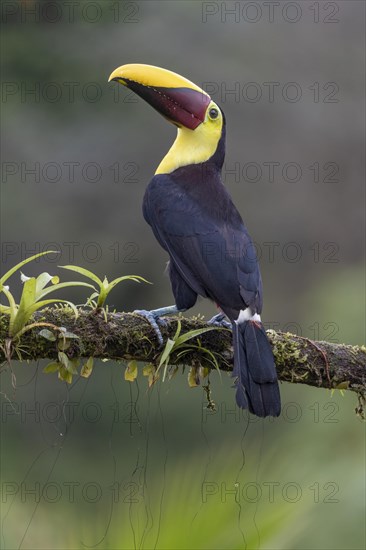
[109,63,211,130]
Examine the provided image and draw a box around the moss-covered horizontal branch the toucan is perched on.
[0,307,366,394]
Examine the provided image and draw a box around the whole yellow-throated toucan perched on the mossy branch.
[109,63,281,417]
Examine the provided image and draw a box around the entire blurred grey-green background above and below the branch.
[1,0,365,550]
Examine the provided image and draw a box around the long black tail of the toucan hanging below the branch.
[233,321,281,416]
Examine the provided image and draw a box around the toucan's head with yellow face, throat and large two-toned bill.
[109,63,224,173]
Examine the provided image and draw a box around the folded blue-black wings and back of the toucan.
[143,174,262,320]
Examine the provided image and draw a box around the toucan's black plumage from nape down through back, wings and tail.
[143,115,280,416]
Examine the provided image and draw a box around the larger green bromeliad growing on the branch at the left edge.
[0,254,95,340]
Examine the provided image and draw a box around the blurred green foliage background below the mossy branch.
[1,363,364,549]
